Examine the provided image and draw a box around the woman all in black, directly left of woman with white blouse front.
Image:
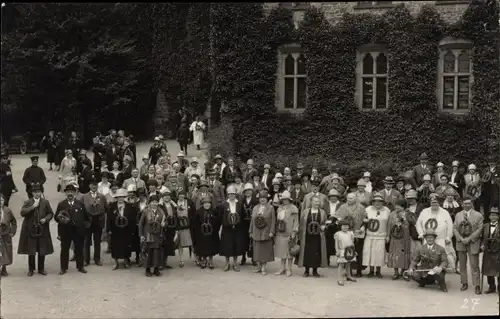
[193,196,220,269]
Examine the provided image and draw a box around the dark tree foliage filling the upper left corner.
[1,3,154,141]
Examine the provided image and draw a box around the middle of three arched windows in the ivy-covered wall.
[356,46,389,110]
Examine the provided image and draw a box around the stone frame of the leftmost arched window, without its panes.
[275,43,308,113]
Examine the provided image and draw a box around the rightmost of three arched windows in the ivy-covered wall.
[438,40,473,112]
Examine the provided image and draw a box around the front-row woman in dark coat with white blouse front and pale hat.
[218,185,248,272]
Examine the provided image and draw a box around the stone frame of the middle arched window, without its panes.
[355,44,390,112]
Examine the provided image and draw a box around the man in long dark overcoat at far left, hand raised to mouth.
[17,184,54,277]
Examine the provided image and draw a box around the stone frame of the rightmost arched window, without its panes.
[436,37,474,114]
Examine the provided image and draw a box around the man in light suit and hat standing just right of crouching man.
[453,198,483,294]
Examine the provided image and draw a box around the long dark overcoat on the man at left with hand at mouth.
[17,198,54,256]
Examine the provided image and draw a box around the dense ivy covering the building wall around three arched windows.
[209,1,500,185]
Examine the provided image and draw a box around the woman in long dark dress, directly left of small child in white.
[297,196,328,277]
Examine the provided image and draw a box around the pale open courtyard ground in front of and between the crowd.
[1,141,499,319]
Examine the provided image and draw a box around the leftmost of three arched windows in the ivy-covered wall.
[278,45,307,110]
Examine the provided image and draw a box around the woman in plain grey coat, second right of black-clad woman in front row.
[249,190,276,275]
